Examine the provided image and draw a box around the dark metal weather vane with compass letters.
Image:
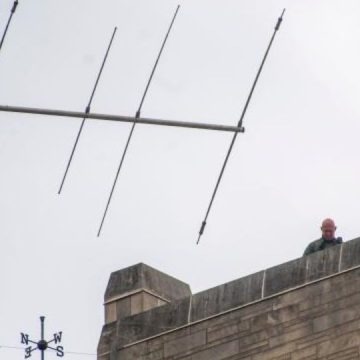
[21,316,64,360]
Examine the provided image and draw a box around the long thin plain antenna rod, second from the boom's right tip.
[97,5,180,237]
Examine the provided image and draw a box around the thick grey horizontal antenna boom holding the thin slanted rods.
[0,105,244,132]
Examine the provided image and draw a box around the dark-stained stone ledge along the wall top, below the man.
[98,238,360,355]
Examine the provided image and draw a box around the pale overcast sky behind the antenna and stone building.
[0,0,360,360]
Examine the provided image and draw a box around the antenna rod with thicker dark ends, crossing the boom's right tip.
[196,9,285,244]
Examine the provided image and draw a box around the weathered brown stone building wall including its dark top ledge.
[98,238,360,360]
